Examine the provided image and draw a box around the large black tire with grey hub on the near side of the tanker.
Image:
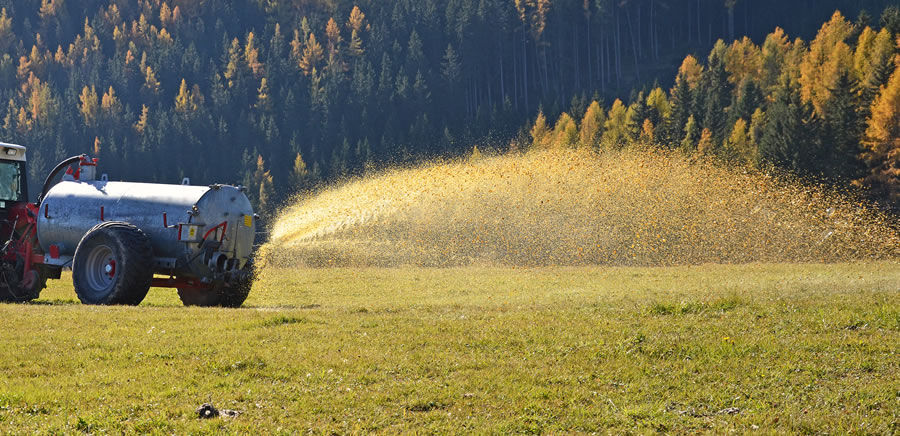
[72,221,153,305]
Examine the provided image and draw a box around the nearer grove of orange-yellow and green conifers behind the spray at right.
[530,12,900,207]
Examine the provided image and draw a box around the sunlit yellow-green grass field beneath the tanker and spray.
[0,262,900,434]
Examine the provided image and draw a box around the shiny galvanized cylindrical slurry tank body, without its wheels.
[37,180,256,278]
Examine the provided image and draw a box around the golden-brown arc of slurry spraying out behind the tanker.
[260,150,900,267]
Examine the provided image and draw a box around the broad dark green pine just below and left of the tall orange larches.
[759,76,820,174]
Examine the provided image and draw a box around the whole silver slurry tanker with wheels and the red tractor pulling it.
[0,143,257,307]
